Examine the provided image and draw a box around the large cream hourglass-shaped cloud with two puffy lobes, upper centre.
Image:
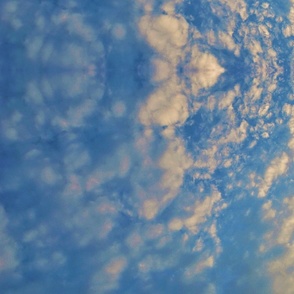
[139,8,189,130]
